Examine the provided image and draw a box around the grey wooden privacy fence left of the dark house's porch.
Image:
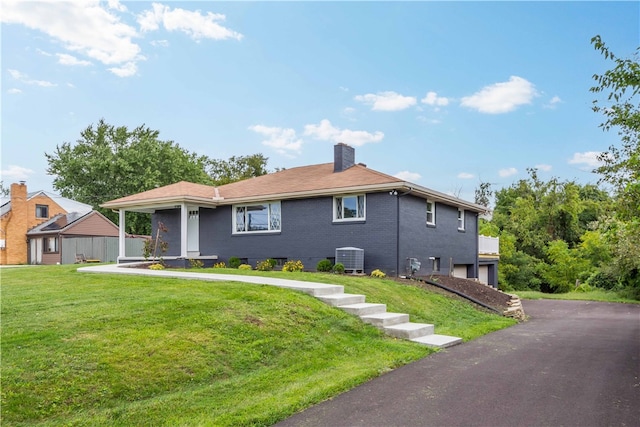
[61,237,146,264]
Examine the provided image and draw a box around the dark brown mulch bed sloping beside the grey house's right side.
[398,276,511,312]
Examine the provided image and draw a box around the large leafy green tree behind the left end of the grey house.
[45,119,212,234]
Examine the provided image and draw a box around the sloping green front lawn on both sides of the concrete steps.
[0,266,514,426]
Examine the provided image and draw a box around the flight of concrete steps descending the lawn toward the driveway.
[315,287,462,348]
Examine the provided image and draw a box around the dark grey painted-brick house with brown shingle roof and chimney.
[102,144,497,285]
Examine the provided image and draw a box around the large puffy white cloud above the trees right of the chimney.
[461,76,538,114]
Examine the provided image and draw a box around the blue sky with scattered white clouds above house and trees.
[0,0,640,200]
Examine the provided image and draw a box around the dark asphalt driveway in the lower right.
[277,300,640,427]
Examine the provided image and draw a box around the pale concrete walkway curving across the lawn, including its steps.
[78,264,462,348]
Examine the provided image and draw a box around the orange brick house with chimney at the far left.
[0,181,92,265]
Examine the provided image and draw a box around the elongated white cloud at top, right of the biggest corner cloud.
[138,3,242,40]
